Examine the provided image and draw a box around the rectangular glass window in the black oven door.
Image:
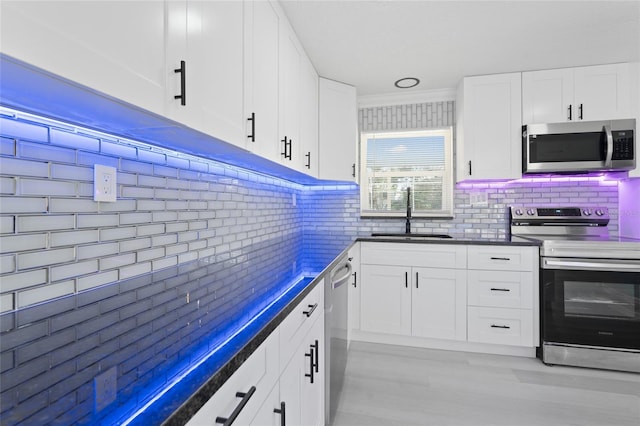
[564,281,637,319]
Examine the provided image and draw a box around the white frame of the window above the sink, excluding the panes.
[360,126,455,218]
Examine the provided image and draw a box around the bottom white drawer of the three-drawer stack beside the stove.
[467,306,535,347]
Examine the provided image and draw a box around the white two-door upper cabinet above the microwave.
[522,63,634,124]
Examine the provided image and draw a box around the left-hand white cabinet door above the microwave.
[522,69,578,124]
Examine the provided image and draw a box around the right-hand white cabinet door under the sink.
[411,268,467,340]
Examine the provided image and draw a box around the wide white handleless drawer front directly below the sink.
[360,243,467,269]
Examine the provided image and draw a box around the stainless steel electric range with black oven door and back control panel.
[510,206,640,372]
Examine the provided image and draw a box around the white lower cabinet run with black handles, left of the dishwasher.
[187,283,325,426]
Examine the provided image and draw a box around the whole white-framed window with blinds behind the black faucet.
[360,127,453,217]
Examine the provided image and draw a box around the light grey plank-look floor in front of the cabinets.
[333,342,640,426]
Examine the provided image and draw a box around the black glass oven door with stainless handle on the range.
[542,258,640,349]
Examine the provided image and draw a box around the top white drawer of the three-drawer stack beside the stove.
[468,246,538,271]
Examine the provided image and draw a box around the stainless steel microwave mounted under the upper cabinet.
[522,119,636,174]
